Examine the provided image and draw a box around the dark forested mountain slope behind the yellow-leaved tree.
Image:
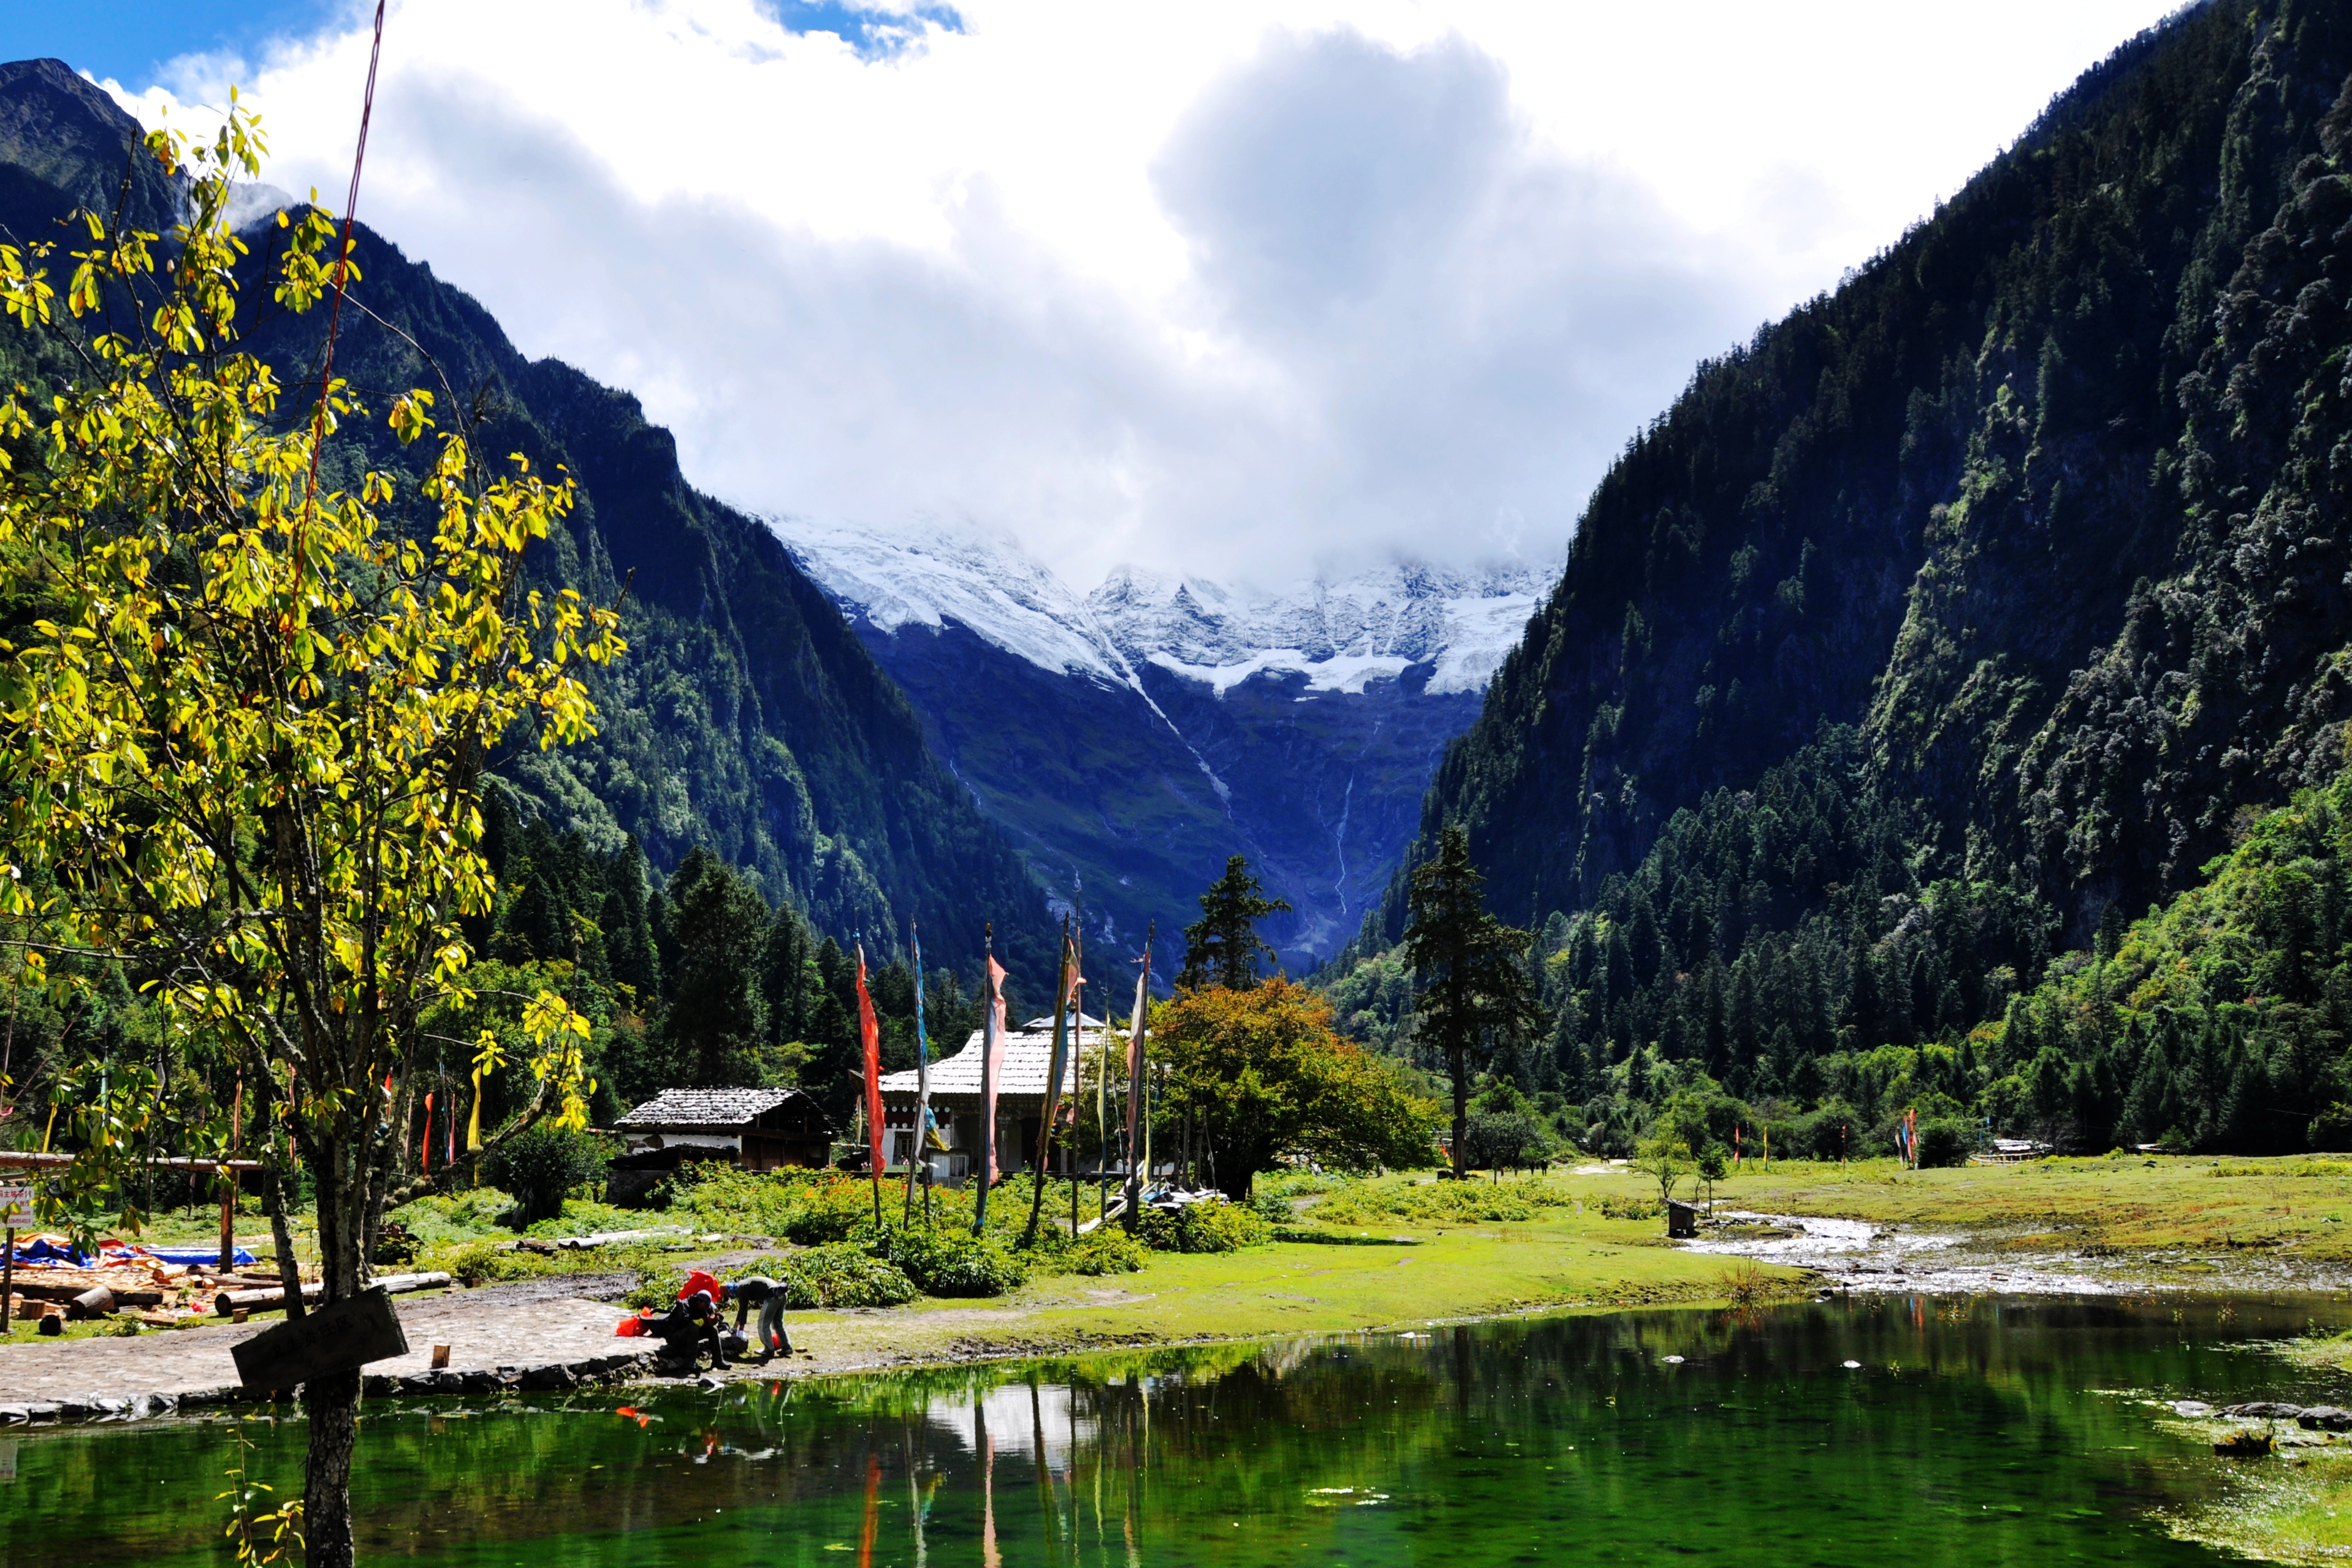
[0,61,1051,992]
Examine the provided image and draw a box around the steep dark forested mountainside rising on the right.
[1355,0,2352,1147]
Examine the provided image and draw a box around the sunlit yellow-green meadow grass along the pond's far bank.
[36,1157,2352,1368]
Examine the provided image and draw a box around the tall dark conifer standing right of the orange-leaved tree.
[1404,828,1533,1176]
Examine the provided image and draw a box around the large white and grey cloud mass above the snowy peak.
[91,0,2164,585]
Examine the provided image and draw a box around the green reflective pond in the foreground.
[0,1298,2352,1568]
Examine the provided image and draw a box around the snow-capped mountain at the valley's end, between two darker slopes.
[774,520,1548,973]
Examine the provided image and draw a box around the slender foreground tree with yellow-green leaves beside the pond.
[0,99,623,1563]
